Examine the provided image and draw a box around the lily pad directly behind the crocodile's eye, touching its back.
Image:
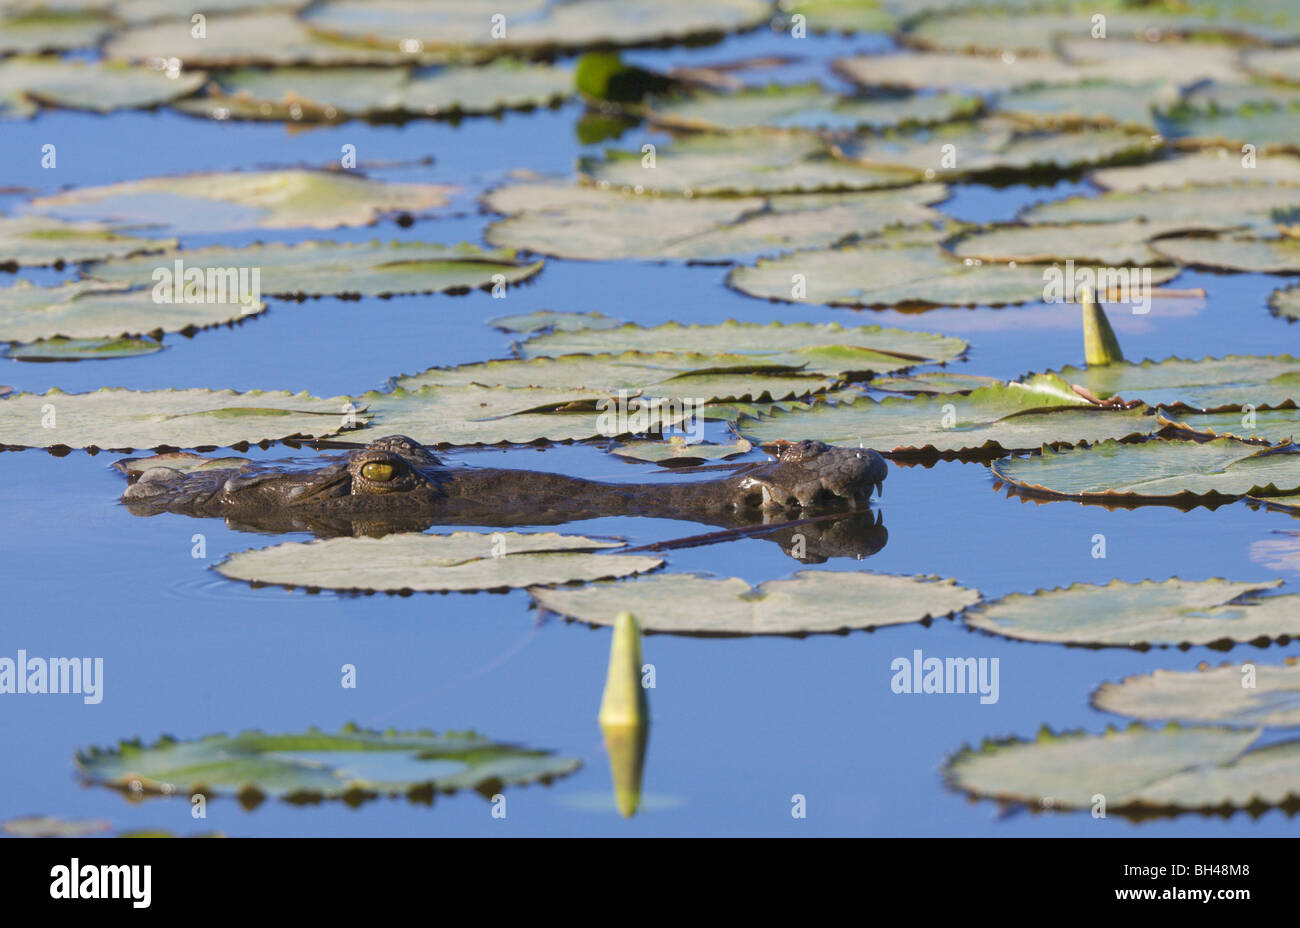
[359,386,693,446]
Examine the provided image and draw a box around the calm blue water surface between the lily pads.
[0,25,1300,836]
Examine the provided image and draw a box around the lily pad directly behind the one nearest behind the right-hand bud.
[948,220,1206,266]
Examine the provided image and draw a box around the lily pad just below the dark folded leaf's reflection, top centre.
[577,130,920,196]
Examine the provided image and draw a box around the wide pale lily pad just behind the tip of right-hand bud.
[727,242,1178,307]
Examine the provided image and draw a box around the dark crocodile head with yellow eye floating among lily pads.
[116,435,887,560]
